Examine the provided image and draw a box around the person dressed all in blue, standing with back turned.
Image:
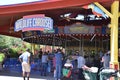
[54,49,63,80]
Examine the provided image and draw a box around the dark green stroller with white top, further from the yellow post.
[83,67,98,80]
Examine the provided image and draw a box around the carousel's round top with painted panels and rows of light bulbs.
[22,23,110,47]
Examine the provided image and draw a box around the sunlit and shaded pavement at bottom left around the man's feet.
[0,71,54,80]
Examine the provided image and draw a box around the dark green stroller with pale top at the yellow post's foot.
[99,69,118,80]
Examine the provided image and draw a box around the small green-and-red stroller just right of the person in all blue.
[62,60,73,80]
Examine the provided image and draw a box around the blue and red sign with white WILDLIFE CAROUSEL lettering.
[14,15,53,32]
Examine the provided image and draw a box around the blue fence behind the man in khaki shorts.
[3,58,53,74]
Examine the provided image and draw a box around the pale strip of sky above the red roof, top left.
[0,0,43,6]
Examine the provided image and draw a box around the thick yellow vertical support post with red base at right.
[110,1,119,69]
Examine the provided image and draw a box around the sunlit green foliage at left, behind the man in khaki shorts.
[0,35,31,57]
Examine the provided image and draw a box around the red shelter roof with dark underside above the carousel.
[0,0,117,38]
